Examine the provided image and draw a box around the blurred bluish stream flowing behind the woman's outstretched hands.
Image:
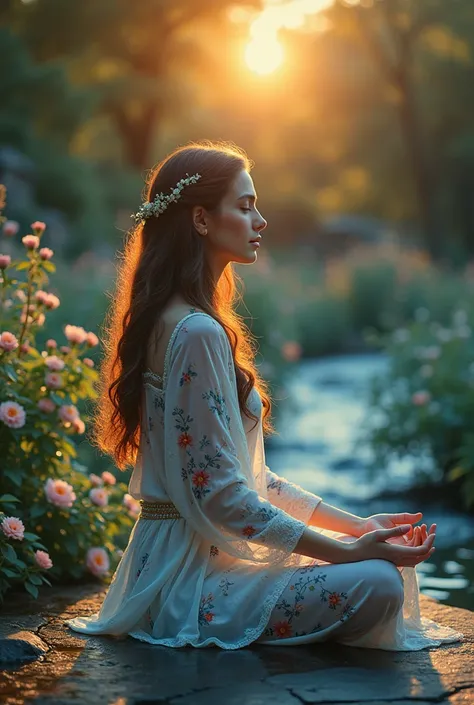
[265,355,474,610]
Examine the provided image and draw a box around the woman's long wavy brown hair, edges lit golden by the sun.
[91,140,274,470]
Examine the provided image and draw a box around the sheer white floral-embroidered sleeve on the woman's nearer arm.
[164,314,306,564]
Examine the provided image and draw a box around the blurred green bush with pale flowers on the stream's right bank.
[359,302,474,510]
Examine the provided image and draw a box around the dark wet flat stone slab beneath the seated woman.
[0,585,474,705]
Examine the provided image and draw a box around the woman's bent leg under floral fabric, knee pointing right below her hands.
[257,559,404,644]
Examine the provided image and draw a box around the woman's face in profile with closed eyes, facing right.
[205,169,267,269]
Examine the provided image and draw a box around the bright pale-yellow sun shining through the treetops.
[245,0,333,75]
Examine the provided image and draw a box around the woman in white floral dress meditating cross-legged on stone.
[66,141,463,650]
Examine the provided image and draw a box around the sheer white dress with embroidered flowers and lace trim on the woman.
[65,312,463,650]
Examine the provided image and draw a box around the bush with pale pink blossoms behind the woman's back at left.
[0,186,139,600]
